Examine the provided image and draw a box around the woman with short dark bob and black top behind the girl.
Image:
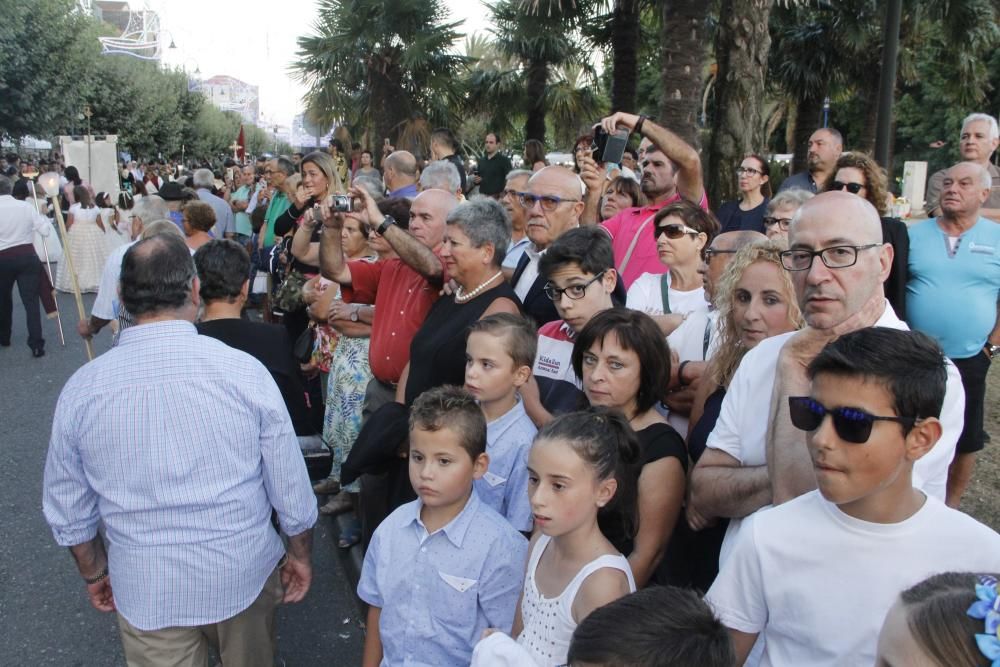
[573,308,687,587]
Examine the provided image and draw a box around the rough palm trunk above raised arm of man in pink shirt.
[660,0,711,149]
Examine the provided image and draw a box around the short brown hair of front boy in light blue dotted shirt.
[410,385,486,461]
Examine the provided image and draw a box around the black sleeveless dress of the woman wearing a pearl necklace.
[406,281,521,406]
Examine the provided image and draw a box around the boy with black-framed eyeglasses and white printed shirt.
[521,227,618,427]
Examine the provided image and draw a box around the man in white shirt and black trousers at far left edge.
[0,176,52,357]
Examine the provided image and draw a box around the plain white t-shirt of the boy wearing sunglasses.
[705,491,1000,667]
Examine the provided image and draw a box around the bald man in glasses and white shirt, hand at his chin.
[690,192,964,564]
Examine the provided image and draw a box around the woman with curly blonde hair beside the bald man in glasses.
[670,240,803,590]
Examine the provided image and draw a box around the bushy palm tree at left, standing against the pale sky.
[292,0,465,154]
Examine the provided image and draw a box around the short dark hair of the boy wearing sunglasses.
[808,327,948,422]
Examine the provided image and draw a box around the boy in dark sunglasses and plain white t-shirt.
[706,327,1000,667]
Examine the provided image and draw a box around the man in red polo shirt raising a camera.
[320,190,458,415]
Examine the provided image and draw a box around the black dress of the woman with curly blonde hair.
[657,387,729,593]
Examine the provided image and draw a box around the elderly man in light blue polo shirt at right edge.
[906,160,1000,508]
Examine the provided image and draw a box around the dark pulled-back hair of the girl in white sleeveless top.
[535,407,642,539]
